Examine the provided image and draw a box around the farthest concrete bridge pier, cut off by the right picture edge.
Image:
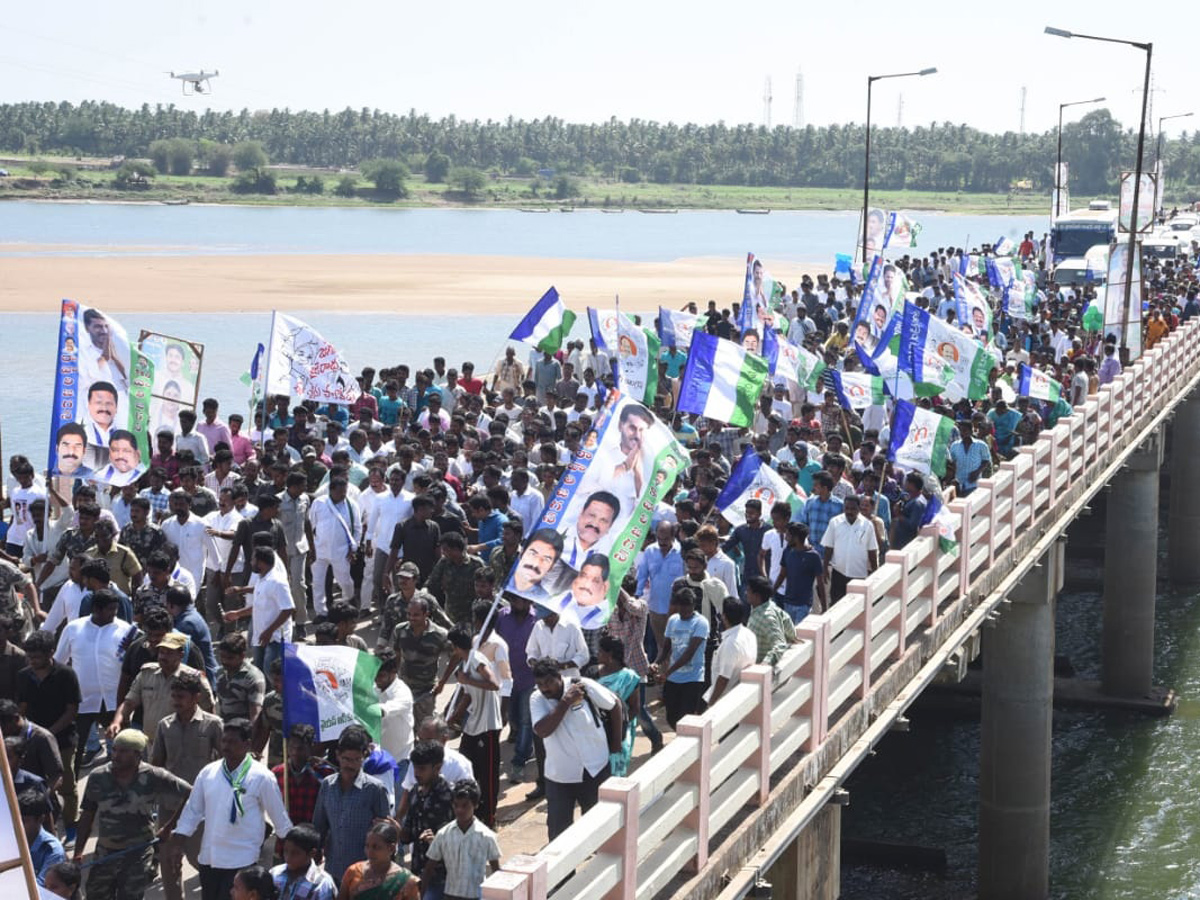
[1166,392,1200,584]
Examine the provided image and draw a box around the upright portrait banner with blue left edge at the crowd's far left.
[47,300,154,486]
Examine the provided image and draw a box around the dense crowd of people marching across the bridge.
[0,225,1200,900]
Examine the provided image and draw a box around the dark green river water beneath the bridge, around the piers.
[842,525,1200,900]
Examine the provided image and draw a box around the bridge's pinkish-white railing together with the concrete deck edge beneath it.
[484,320,1200,900]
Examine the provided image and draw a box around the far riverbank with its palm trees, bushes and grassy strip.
[0,102,1200,212]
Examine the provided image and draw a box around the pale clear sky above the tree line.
[0,0,1200,134]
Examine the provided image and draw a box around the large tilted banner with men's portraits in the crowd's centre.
[504,390,689,629]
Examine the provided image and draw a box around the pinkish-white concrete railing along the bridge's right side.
[484,322,1200,900]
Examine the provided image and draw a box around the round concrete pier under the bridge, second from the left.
[979,541,1064,900]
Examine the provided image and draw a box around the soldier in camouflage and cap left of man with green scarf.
[74,728,192,900]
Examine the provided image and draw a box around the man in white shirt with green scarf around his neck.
[167,720,292,900]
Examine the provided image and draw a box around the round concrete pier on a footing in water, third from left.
[1100,429,1156,698]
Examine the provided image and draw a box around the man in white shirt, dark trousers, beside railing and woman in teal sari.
[529,660,625,840]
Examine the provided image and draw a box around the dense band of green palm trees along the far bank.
[0,102,1200,196]
